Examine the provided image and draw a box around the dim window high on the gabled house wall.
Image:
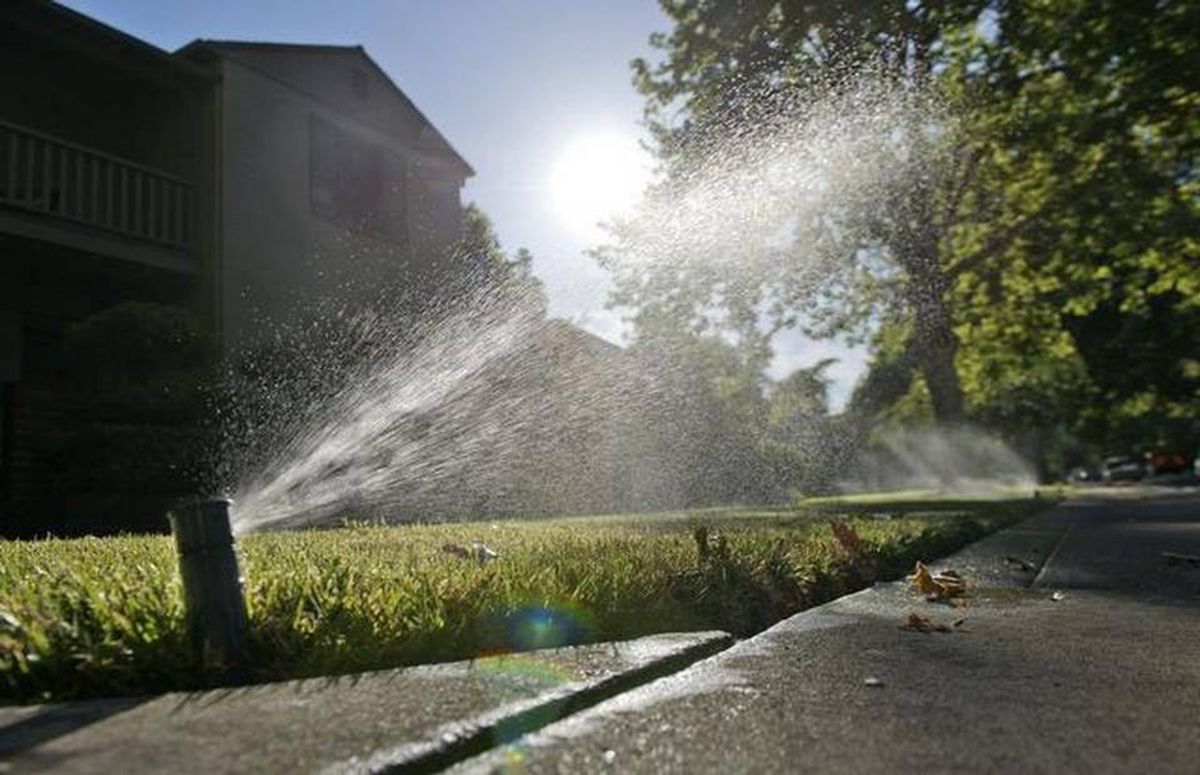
[308,116,407,240]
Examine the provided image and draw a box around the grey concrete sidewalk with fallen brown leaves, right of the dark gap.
[457,494,1200,773]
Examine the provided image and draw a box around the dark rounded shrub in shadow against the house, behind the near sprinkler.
[51,301,217,530]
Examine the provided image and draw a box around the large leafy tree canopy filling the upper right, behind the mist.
[609,0,1200,477]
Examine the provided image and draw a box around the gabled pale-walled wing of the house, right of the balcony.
[175,41,474,350]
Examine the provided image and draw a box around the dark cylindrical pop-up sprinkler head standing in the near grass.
[167,498,246,668]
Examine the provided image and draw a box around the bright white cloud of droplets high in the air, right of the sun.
[609,76,948,285]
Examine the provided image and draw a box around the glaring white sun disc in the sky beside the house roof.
[550,136,650,239]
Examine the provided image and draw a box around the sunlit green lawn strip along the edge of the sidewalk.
[0,500,1037,702]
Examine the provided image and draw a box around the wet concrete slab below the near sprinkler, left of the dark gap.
[0,632,730,773]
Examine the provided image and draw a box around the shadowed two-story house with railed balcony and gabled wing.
[0,0,473,529]
